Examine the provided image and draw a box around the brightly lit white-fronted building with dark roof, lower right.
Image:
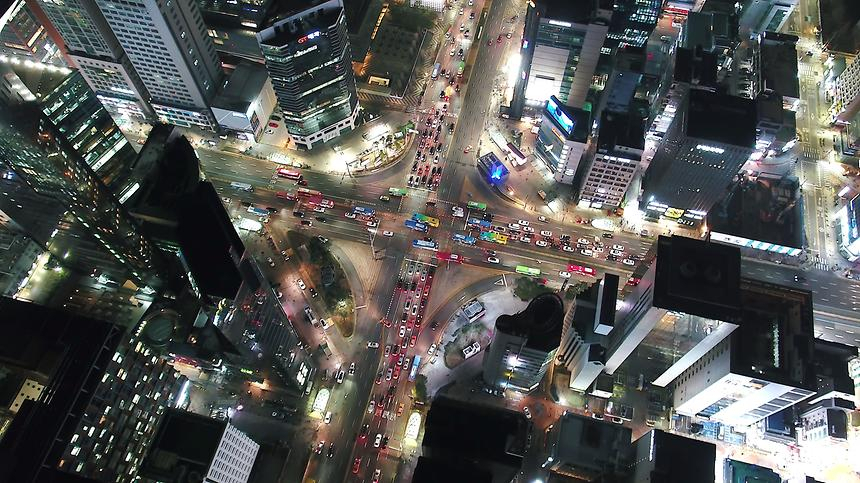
[673,279,817,426]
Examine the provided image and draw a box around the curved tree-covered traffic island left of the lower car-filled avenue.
[287,231,355,338]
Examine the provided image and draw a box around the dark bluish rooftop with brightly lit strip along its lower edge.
[708,175,805,248]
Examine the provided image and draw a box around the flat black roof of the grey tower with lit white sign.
[686,89,758,149]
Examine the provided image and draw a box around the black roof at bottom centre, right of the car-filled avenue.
[421,397,529,481]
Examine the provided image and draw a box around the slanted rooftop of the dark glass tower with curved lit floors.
[257,0,344,46]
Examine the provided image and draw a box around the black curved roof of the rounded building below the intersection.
[496,293,564,352]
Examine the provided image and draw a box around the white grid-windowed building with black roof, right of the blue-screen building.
[579,111,645,208]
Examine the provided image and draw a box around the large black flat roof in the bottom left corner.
[0,297,124,482]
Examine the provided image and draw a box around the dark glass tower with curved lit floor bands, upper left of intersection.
[257,0,359,149]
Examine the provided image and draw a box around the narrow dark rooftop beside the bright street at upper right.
[759,32,800,99]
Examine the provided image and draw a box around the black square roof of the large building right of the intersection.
[654,236,741,322]
